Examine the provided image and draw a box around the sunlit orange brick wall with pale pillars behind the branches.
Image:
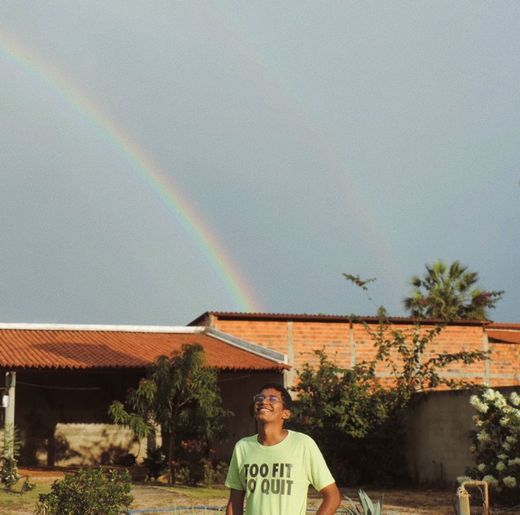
[207,314,520,392]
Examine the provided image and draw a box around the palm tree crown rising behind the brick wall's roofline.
[404,260,504,321]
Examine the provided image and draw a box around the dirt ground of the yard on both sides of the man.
[14,468,520,515]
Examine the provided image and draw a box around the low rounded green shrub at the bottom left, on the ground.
[37,468,133,515]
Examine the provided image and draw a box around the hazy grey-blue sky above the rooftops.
[0,0,520,324]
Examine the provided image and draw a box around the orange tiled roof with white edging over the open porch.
[0,324,287,371]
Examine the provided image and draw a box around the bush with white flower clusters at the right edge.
[466,388,520,504]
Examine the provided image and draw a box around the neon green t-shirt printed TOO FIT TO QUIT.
[226,431,334,515]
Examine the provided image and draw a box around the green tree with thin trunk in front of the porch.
[109,345,230,483]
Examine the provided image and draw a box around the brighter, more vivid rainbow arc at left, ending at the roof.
[0,27,260,311]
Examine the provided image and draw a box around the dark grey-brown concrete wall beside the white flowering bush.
[406,388,515,485]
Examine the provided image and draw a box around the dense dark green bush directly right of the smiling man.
[289,351,405,486]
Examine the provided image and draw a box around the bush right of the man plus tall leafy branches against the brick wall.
[293,309,487,484]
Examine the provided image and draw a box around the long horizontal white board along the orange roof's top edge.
[0,323,205,334]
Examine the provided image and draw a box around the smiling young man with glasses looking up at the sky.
[226,384,341,515]
